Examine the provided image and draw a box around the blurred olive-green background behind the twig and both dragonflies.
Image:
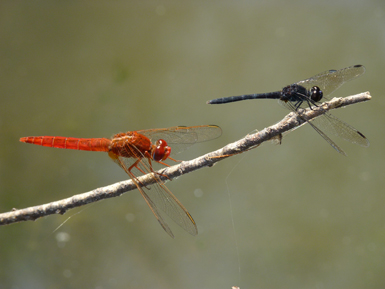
[0,0,385,289]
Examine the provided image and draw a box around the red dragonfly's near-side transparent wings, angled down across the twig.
[109,147,198,238]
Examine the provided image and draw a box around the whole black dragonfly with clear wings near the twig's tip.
[207,65,369,156]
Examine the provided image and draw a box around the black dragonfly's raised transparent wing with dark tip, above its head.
[297,65,365,98]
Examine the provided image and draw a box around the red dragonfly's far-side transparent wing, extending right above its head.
[137,125,222,154]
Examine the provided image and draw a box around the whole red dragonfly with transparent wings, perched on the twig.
[20,125,222,238]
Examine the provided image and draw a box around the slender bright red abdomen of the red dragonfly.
[20,136,111,152]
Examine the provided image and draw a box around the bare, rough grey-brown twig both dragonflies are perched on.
[0,92,371,225]
